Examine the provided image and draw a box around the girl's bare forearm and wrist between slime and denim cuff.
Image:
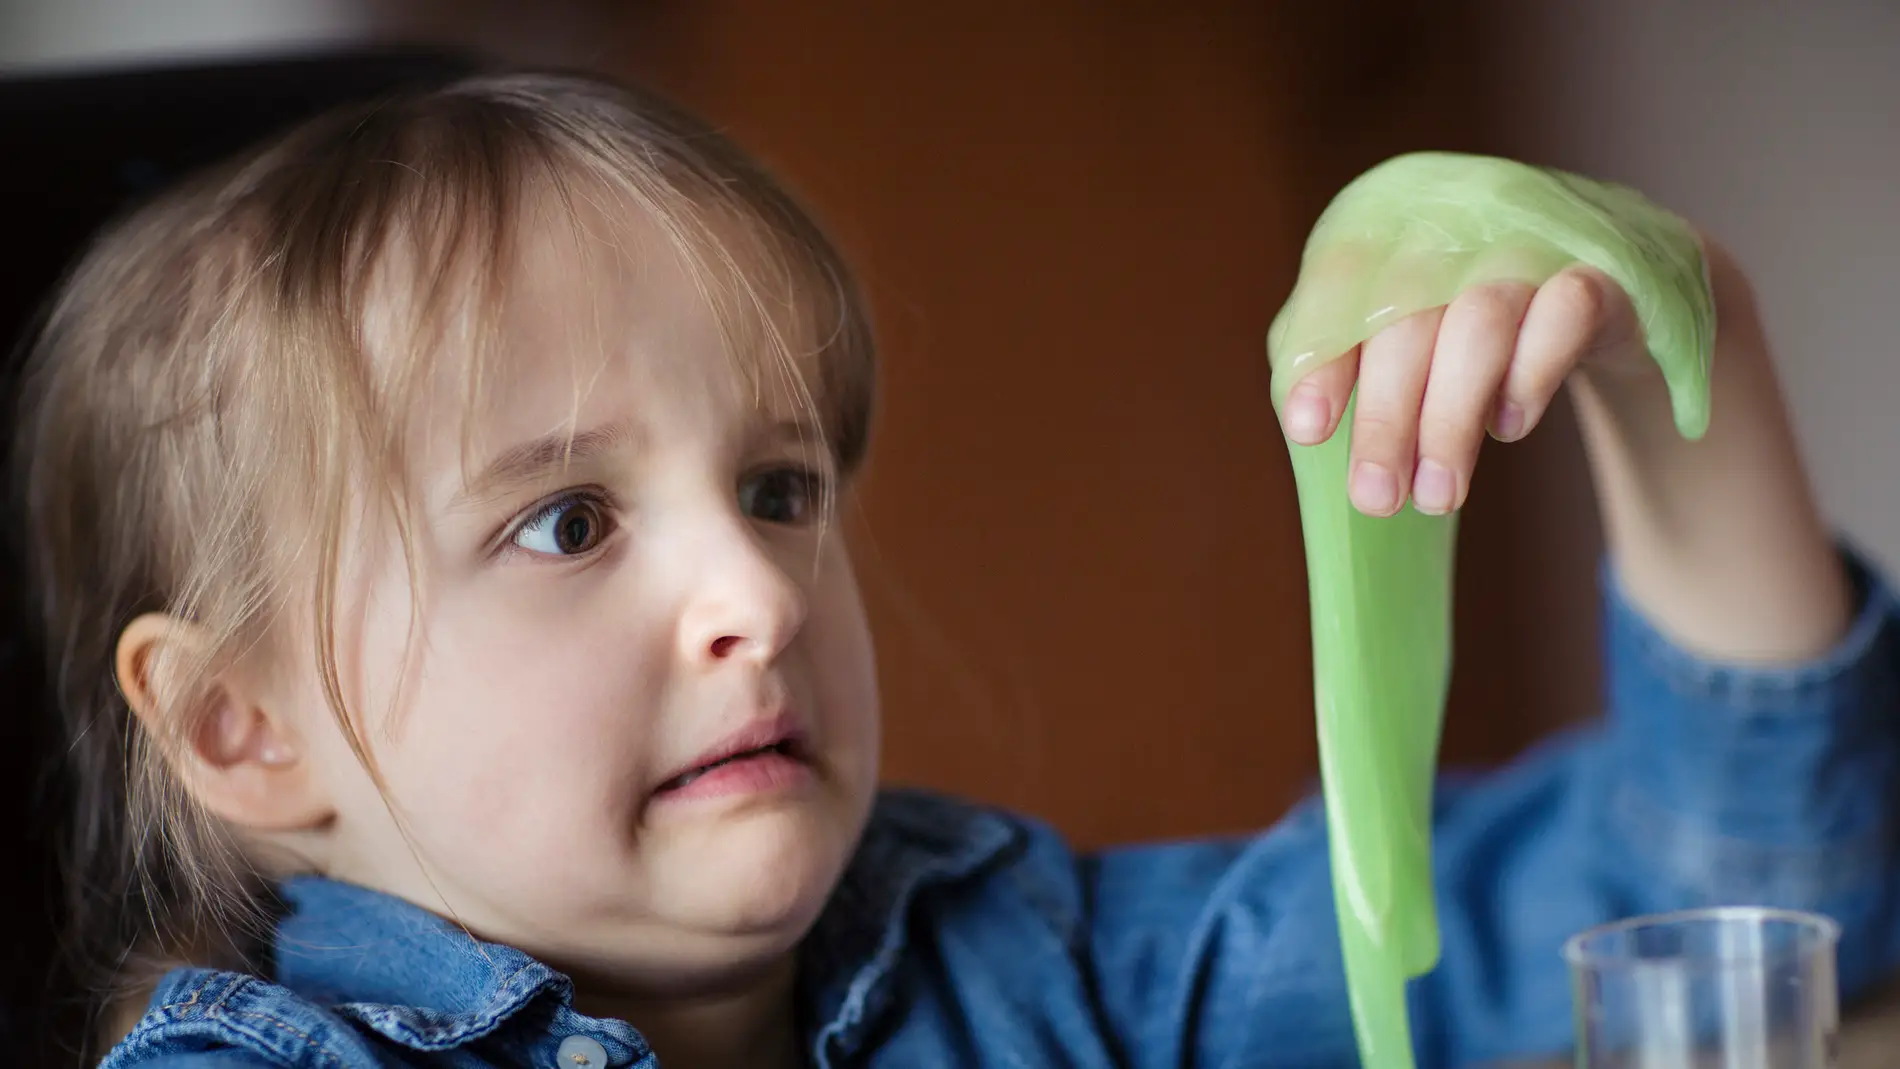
[1571,243,1851,663]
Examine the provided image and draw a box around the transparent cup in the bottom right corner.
[1564,908,1839,1069]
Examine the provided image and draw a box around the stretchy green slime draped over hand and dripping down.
[1267,152,1716,1069]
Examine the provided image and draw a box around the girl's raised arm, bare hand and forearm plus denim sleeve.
[1085,224,1900,1065]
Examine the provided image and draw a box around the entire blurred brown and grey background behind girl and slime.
[0,0,1900,858]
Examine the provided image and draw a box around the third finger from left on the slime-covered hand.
[1412,283,1537,515]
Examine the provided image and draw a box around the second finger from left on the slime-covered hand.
[1347,308,1442,516]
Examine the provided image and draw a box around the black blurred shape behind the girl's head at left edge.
[0,53,475,1065]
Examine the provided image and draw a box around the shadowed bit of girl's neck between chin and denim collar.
[576,957,806,1069]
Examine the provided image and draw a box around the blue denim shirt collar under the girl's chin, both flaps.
[264,792,1018,1065]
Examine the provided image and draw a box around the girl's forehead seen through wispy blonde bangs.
[357,183,823,480]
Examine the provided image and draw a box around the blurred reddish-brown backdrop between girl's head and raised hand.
[614,0,1596,843]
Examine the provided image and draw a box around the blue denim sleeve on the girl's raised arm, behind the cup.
[1083,550,1900,1069]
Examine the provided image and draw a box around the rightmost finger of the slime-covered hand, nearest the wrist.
[1492,264,1642,442]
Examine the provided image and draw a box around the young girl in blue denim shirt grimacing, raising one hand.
[17,68,1900,1069]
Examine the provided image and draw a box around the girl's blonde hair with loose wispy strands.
[15,65,874,1048]
